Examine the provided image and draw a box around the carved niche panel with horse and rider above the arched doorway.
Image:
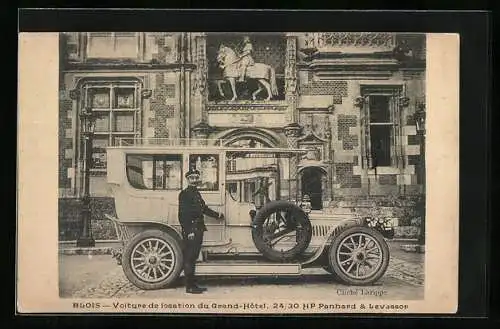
[206,34,285,103]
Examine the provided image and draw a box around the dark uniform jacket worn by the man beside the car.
[179,185,219,234]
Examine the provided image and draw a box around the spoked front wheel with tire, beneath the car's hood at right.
[328,226,390,286]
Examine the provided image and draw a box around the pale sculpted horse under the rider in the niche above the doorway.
[217,45,278,101]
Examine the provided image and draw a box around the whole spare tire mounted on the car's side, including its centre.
[252,200,312,262]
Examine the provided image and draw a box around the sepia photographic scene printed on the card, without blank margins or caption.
[59,32,426,301]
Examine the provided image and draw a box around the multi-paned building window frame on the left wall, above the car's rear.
[79,78,143,175]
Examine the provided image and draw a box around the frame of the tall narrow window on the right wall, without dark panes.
[361,85,404,169]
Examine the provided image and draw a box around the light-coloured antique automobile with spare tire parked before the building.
[106,139,391,290]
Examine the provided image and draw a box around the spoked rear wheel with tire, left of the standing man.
[122,230,183,290]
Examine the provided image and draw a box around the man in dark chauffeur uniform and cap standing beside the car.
[179,169,224,294]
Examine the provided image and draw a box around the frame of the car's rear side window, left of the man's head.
[125,153,184,192]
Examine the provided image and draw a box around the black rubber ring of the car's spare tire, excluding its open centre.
[252,200,312,262]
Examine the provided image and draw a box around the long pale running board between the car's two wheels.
[196,262,301,276]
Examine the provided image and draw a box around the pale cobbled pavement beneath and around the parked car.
[59,241,424,299]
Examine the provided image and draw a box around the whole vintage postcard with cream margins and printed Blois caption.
[17,31,459,314]
